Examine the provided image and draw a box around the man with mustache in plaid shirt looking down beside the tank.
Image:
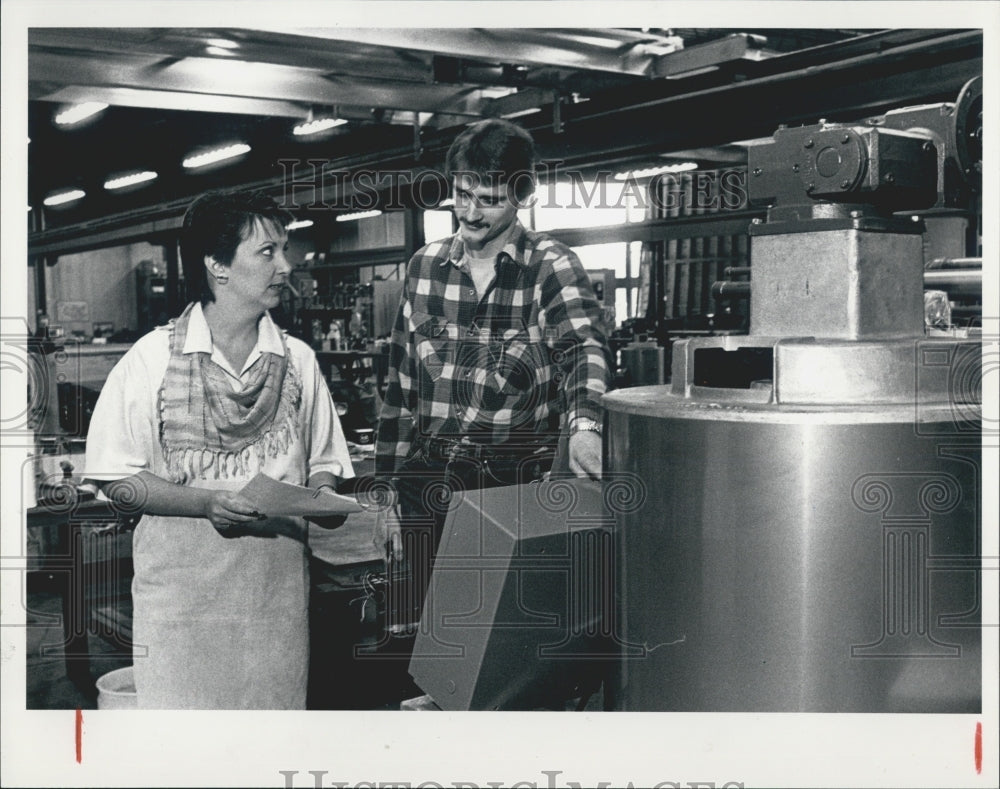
[375,120,611,633]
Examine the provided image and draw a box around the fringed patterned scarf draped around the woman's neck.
[159,304,302,484]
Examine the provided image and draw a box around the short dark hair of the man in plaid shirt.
[445,118,535,201]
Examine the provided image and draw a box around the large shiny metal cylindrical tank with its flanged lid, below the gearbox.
[604,336,982,713]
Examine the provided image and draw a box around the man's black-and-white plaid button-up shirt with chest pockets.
[375,222,611,473]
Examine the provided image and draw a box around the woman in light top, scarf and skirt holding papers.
[86,192,354,709]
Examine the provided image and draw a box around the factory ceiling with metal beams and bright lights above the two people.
[28,27,982,254]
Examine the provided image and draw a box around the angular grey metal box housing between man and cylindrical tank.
[409,478,615,711]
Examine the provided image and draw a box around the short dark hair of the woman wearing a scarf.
[181,190,293,304]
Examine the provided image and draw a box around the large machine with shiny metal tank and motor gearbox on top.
[604,80,982,713]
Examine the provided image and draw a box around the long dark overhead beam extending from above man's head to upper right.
[525,33,983,163]
